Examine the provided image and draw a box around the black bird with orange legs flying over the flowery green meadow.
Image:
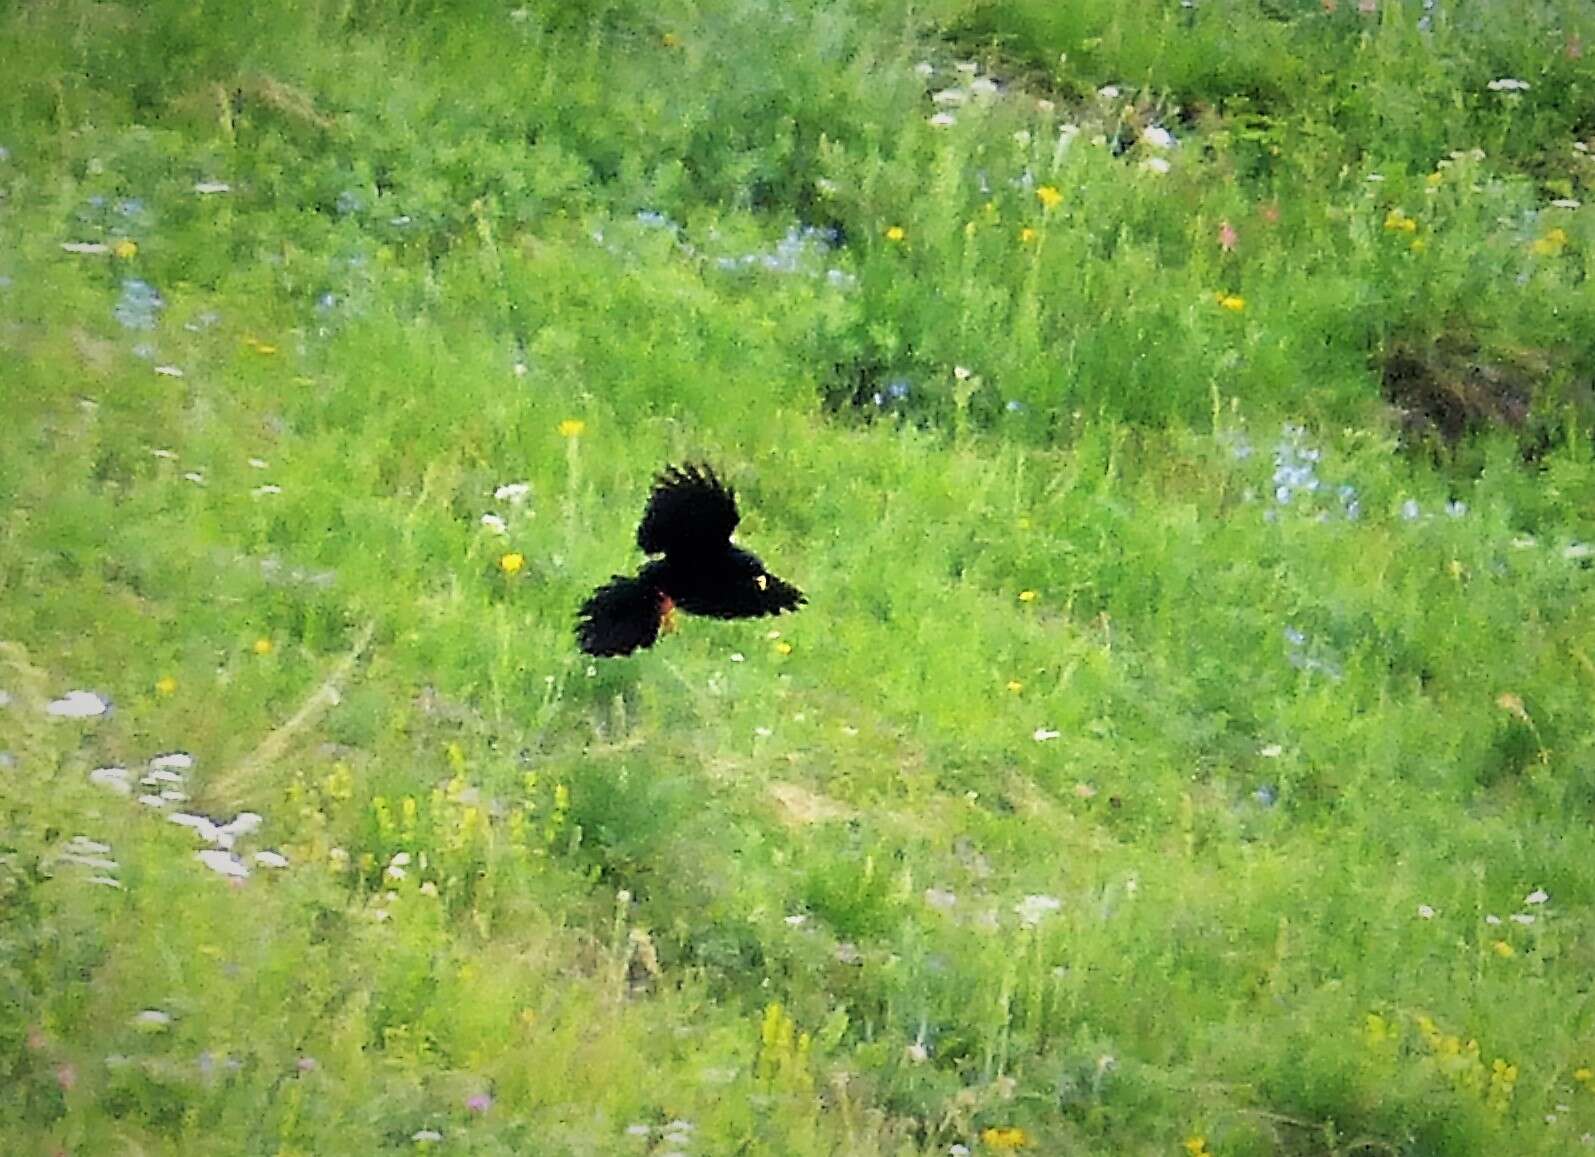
[576,464,807,656]
